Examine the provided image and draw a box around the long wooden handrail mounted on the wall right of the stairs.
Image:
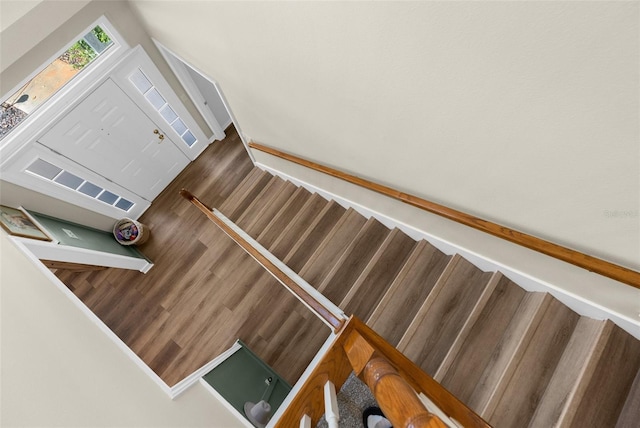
[249,141,640,288]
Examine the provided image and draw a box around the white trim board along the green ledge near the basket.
[19,237,153,273]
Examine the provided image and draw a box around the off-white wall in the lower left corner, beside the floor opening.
[0,232,243,428]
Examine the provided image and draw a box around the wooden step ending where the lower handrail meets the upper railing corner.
[339,229,417,320]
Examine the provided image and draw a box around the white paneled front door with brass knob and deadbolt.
[39,78,189,201]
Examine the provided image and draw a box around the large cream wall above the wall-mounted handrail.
[131,0,640,269]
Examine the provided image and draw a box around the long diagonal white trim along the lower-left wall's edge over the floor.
[10,238,172,397]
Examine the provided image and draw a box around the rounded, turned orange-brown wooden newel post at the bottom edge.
[362,356,445,428]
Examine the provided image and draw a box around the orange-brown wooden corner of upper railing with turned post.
[274,317,489,428]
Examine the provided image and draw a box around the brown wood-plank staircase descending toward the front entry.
[219,168,640,427]
